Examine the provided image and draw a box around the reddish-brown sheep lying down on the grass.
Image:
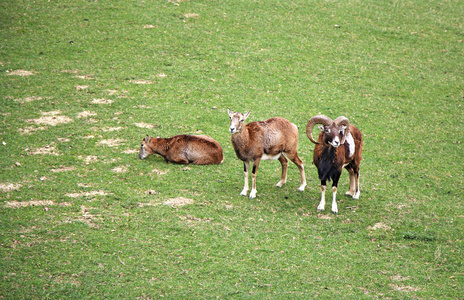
[139,135,224,165]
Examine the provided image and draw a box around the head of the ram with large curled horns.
[306,115,350,148]
